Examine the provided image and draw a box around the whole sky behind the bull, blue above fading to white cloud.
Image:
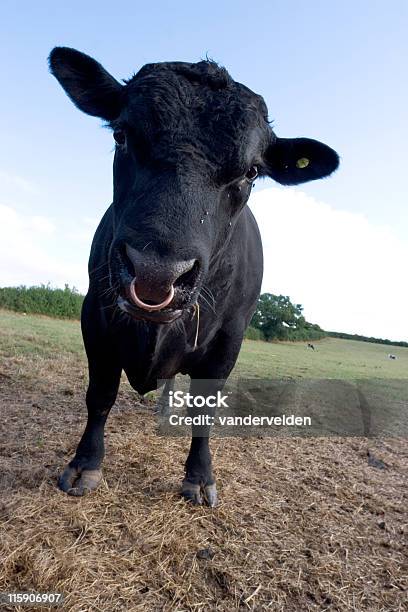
[0,0,408,339]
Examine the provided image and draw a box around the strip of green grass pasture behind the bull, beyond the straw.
[0,310,408,380]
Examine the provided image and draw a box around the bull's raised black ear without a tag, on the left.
[48,47,124,121]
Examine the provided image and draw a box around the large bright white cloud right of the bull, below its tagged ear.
[251,187,408,340]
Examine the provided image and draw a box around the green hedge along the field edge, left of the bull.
[0,285,84,319]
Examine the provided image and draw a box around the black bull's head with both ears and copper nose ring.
[50,47,338,322]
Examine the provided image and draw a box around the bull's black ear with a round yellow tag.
[264,138,339,185]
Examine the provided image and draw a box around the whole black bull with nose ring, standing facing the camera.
[49,47,338,506]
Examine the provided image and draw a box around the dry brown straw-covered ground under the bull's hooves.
[0,314,408,612]
